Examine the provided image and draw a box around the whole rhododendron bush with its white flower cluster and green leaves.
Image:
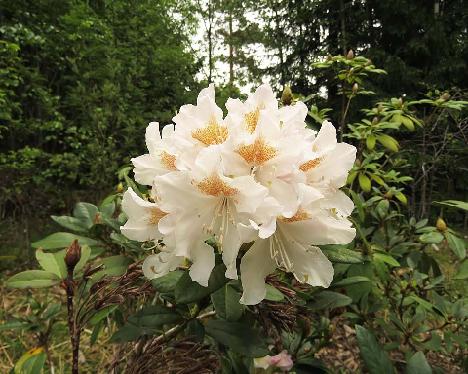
[4,52,468,374]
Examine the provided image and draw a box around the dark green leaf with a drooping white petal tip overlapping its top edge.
[175,264,228,304]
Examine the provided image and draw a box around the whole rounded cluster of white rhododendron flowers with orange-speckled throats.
[121,85,356,304]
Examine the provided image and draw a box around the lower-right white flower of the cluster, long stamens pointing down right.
[240,194,356,305]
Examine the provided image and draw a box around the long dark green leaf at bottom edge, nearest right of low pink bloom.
[355,325,394,374]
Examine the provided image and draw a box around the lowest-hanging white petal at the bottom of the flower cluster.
[240,239,276,305]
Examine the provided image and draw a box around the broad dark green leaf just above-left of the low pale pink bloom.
[205,319,268,357]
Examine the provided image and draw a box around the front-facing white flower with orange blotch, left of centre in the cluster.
[155,152,268,279]
